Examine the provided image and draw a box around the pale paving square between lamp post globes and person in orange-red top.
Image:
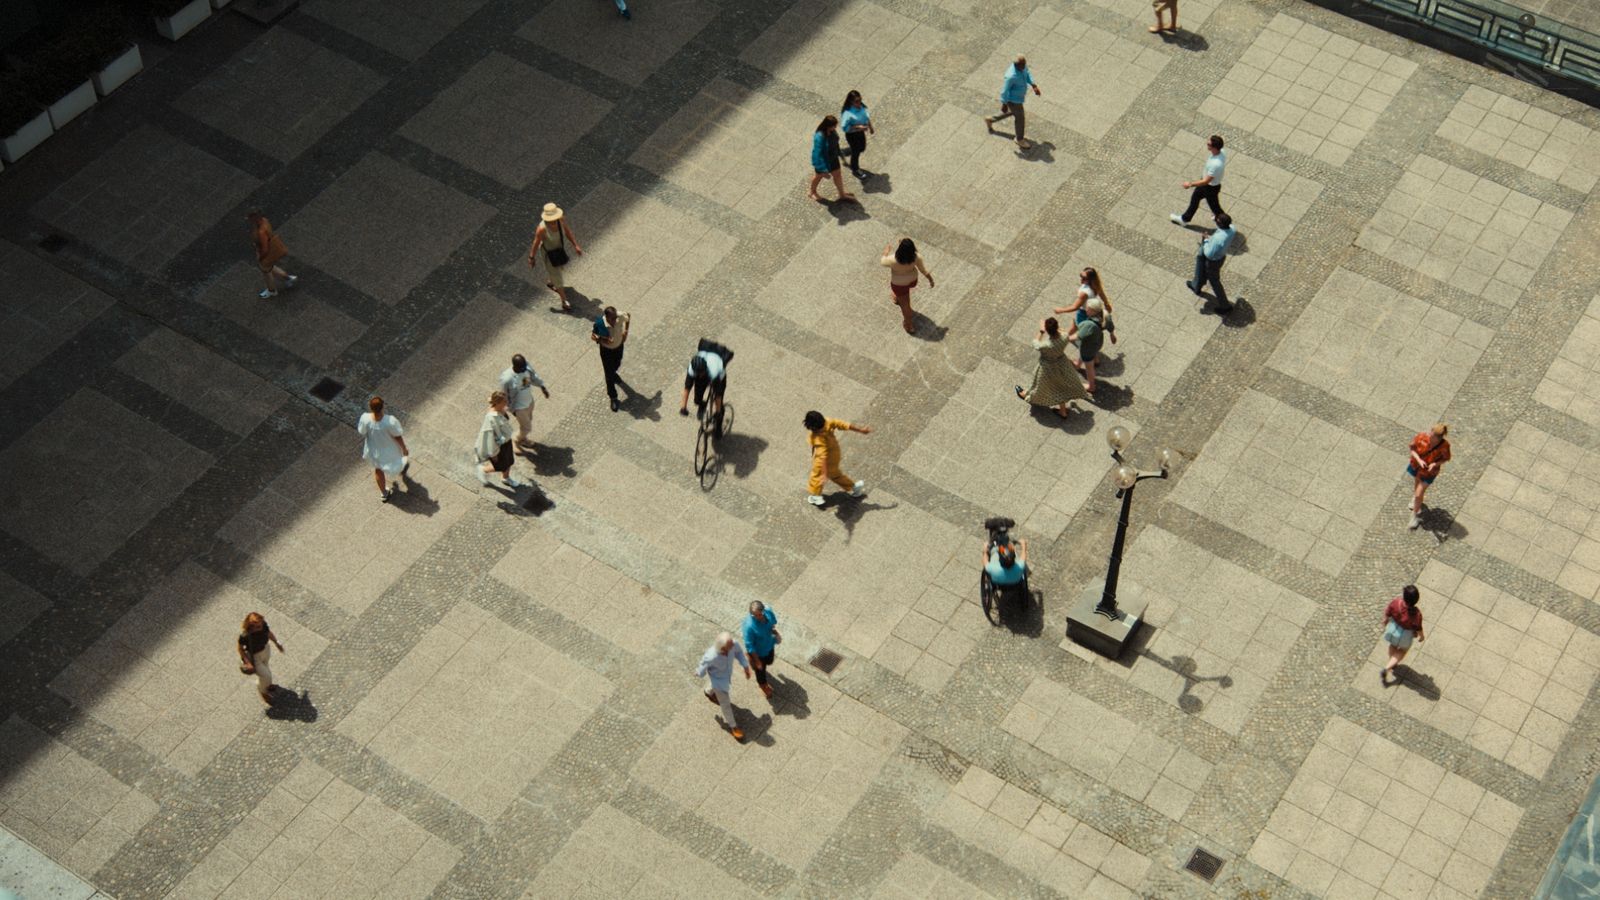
[1173,391,1405,575]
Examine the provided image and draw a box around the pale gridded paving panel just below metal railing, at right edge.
[1437,85,1600,194]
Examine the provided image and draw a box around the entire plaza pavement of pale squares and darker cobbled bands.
[0,0,1600,900]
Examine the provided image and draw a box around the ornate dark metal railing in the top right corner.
[1357,0,1600,88]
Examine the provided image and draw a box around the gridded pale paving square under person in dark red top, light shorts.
[1355,560,1600,777]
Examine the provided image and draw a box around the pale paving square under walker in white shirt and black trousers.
[1107,131,1322,278]
